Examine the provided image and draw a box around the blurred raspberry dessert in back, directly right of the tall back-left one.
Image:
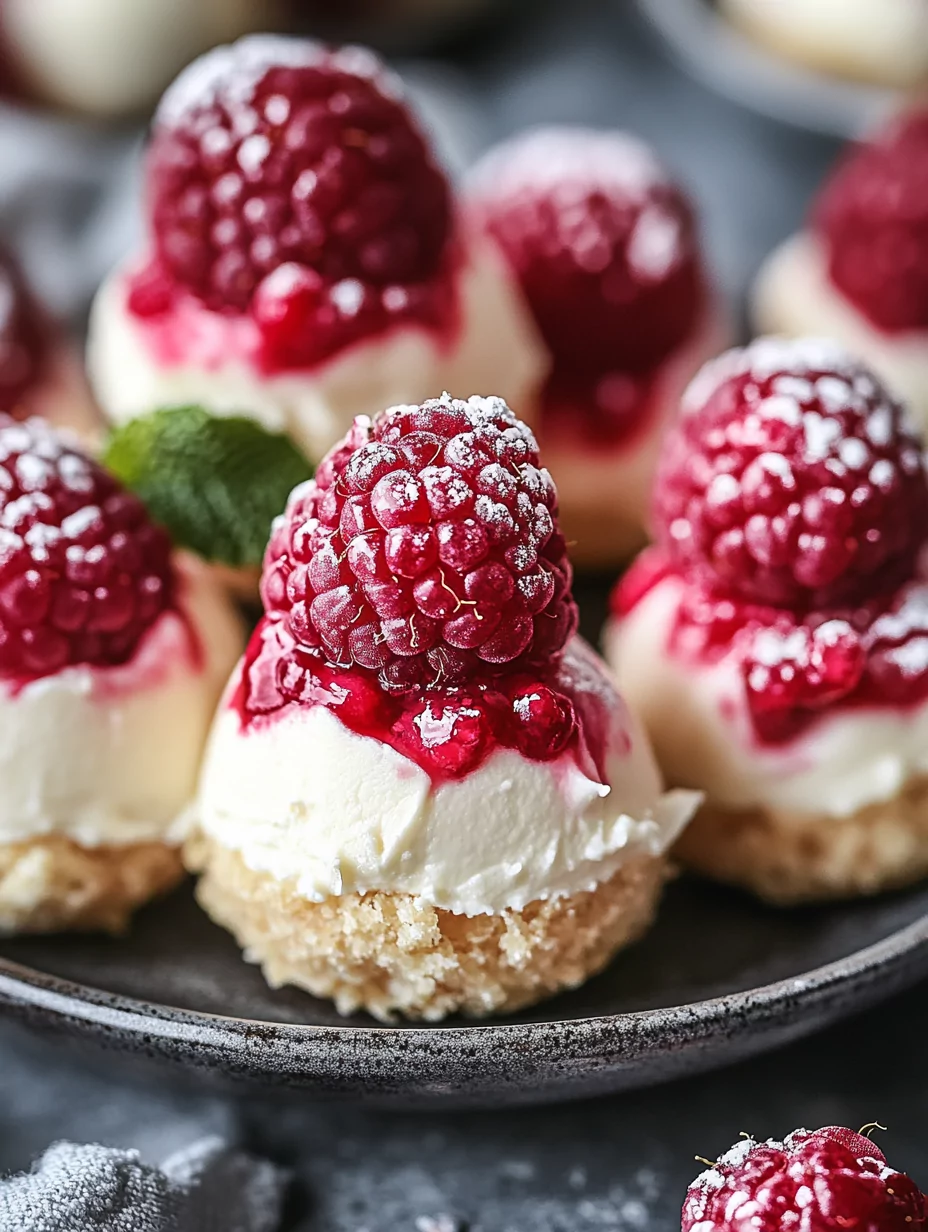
[467,128,727,565]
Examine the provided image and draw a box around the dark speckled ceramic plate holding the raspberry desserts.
[0,580,928,1104]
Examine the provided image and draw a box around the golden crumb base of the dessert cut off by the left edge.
[0,834,184,936]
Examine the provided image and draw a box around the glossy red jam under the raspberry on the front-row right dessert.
[614,549,928,744]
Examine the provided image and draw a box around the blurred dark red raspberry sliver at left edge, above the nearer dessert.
[0,249,53,419]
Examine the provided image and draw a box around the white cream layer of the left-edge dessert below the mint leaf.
[0,564,242,846]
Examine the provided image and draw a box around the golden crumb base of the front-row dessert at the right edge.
[674,779,928,906]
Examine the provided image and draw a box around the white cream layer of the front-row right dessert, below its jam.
[608,578,928,818]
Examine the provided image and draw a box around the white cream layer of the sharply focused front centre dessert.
[198,650,698,915]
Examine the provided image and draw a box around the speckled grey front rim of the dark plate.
[0,912,928,1101]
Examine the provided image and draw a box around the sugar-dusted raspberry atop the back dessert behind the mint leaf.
[142,36,451,310]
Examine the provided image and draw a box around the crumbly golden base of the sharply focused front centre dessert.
[185,837,667,1021]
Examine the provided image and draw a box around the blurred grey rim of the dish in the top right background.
[638,0,898,137]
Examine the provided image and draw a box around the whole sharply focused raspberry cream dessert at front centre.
[189,397,695,1019]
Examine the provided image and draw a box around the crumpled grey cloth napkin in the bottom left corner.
[0,1137,286,1232]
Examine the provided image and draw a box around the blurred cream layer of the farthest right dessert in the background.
[754,235,928,432]
